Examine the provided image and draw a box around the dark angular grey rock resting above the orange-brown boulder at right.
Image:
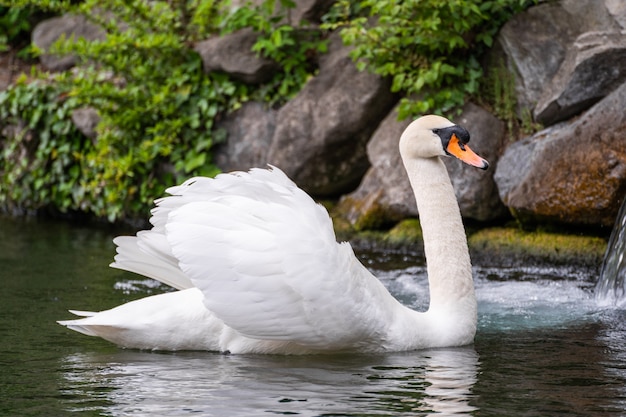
[534,32,626,126]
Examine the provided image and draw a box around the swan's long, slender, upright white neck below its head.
[404,157,475,315]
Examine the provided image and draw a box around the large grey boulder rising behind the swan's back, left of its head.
[268,35,396,196]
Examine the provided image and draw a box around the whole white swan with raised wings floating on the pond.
[59,115,488,354]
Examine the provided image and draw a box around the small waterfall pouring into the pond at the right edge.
[595,199,626,308]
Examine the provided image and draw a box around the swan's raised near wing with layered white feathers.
[161,169,400,349]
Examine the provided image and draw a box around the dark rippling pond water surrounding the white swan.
[0,218,626,417]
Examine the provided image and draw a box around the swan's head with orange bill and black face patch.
[400,115,489,169]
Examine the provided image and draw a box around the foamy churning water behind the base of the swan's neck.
[366,265,598,332]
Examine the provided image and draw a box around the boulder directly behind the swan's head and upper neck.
[337,103,506,229]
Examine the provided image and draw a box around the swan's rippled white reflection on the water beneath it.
[61,347,479,416]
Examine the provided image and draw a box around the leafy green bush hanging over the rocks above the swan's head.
[326,0,531,118]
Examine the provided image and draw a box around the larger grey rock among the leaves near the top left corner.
[31,14,106,71]
